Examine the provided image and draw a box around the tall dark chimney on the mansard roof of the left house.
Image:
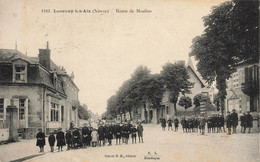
[39,41,51,70]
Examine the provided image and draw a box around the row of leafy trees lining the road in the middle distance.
[106,62,192,118]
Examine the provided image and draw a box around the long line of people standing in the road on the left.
[36,122,144,152]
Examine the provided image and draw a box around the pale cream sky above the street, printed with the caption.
[0,0,224,115]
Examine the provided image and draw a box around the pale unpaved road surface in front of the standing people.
[0,124,260,162]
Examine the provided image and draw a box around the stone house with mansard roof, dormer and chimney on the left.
[0,44,79,138]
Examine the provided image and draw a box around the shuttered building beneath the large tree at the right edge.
[225,61,259,113]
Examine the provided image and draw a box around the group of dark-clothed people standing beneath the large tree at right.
[160,109,253,135]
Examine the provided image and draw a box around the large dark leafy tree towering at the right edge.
[190,0,259,113]
